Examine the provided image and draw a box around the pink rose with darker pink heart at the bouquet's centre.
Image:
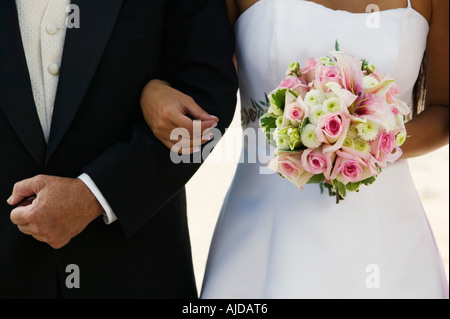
[317,112,350,153]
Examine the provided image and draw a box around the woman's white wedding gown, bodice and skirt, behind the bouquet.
[202,0,448,299]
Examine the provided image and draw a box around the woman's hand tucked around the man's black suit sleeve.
[141,80,219,153]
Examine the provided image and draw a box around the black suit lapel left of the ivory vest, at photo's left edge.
[0,0,47,165]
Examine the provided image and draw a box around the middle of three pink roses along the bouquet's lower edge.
[302,148,336,180]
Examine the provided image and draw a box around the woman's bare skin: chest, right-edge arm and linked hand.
[142,0,449,158]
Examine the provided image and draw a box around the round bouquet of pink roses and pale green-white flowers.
[260,51,410,203]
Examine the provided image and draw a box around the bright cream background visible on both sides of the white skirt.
[187,100,449,291]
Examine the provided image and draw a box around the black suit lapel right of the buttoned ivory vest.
[46,0,123,162]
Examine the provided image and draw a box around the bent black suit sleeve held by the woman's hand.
[84,0,237,236]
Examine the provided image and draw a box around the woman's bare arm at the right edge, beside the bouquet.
[402,0,449,158]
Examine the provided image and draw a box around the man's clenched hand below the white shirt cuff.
[8,175,103,249]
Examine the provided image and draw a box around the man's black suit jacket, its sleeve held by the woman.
[0,0,237,298]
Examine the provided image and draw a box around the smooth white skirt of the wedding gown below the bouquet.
[202,146,448,299]
